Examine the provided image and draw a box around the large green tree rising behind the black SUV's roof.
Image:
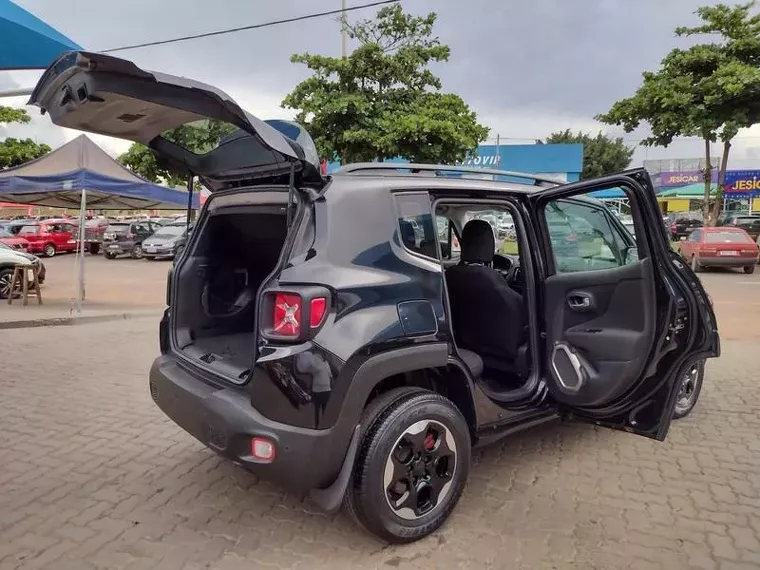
[282,5,488,164]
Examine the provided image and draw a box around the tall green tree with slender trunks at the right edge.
[597,1,760,225]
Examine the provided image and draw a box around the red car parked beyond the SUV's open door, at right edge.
[680,227,760,274]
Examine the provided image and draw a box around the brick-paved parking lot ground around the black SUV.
[0,256,760,570]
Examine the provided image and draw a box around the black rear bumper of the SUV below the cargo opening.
[150,355,348,493]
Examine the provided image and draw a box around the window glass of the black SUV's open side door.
[545,198,639,273]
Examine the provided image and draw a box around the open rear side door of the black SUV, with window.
[529,170,720,439]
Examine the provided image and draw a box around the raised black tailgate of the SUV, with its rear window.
[29,51,322,191]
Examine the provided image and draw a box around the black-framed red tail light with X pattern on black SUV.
[260,286,330,341]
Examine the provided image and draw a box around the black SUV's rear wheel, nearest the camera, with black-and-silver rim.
[345,388,471,543]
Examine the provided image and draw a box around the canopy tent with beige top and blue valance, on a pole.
[0,135,199,311]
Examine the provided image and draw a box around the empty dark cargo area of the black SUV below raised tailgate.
[172,192,287,382]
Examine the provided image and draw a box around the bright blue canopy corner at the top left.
[0,0,81,70]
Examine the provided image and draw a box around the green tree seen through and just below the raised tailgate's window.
[117,120,236,187]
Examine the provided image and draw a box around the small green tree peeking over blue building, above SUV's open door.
[546,129,633,180]
